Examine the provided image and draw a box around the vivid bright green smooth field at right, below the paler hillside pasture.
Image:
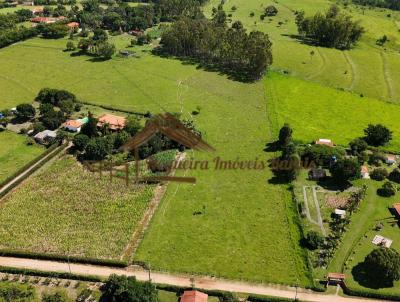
[265,73,400,151]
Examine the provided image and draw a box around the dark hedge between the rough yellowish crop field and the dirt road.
[0,250,129,267]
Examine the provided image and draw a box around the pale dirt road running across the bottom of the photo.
[0,257,382,302]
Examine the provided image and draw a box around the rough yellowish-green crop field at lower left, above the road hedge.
[0,156,153,259]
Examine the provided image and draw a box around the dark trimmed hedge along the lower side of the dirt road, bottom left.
[0,266,104,282]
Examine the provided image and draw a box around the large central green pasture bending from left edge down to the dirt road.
[0,37,310,286]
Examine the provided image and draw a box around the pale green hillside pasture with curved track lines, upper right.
[206,0,400,102]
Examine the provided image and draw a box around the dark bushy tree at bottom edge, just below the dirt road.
[102,275,158,302]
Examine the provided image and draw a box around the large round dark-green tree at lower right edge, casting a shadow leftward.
[364,247,400,282]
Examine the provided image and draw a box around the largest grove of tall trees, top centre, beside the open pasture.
[161,5,272,80]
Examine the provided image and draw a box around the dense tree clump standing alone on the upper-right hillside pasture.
[296,5,364,49]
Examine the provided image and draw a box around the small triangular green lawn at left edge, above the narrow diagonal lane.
[0,131,44,183]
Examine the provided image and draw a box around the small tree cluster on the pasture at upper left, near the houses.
[77,29,116,60]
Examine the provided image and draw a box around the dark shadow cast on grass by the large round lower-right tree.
[351,262,393,289]
